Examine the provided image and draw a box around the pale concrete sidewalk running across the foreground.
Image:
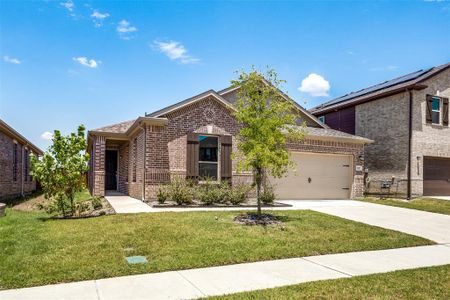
[0,245,450,300]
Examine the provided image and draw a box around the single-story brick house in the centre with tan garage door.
[88,88,371,199]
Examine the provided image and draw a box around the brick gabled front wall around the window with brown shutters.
[146,98,251,199]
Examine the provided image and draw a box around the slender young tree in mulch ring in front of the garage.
[232,69,304,215]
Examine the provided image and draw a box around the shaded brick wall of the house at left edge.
[0,132,36,200]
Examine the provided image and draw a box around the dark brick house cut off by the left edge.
[0,119,43,201]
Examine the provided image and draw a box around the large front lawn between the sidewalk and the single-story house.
[0,209,433,289]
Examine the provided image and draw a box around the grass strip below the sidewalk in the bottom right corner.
[208,265,450,300]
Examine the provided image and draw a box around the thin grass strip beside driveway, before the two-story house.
[356,197,450,215]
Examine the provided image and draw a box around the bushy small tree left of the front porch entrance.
[31,125,89,216]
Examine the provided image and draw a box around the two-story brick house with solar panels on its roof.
[311,63,450,198]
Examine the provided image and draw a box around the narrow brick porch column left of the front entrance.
[92,136,106,196]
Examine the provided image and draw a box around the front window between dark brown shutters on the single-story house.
[198,135,219,180]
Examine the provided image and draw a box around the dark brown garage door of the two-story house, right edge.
[423,156,450,196]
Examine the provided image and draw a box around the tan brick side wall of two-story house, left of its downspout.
[355,92,409,195]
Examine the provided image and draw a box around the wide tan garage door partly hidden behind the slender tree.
[270,152,353,199]
